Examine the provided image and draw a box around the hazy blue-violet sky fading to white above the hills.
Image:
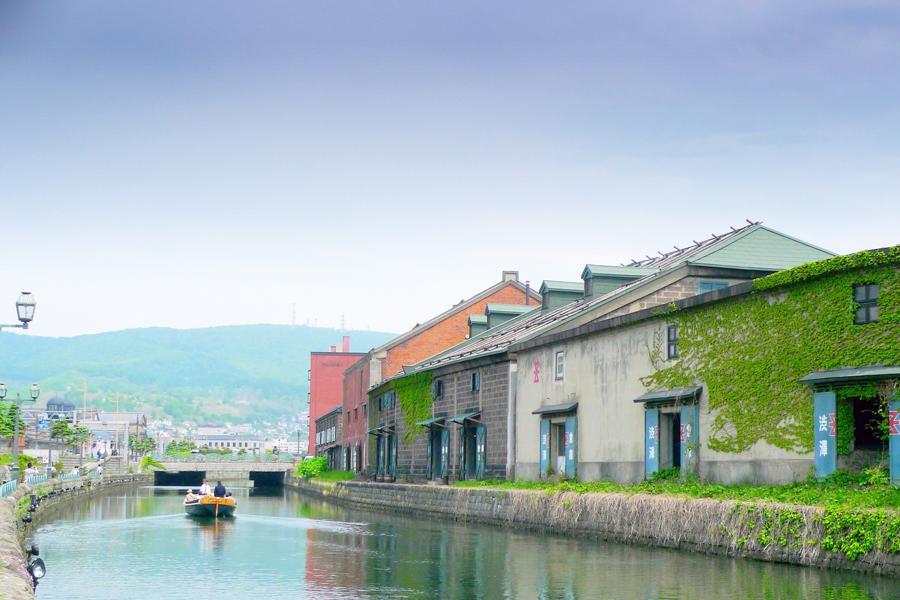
[0,0,900,336]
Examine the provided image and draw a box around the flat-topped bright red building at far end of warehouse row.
[308,336,366,454]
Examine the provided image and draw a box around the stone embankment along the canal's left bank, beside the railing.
[0,474,150,600]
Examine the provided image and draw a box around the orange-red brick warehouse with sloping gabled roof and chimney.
[343,271,541,471]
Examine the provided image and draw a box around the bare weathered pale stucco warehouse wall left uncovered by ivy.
[516,318,812,483]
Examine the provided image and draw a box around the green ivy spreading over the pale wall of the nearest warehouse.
[643,247,900,452]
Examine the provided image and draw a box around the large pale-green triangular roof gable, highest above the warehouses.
[688,225,834,271]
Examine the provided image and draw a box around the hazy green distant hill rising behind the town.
[0,325,394,421]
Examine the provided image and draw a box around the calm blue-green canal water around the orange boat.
[35,486,900,600]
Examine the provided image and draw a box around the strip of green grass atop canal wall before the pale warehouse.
[454,471,900,510]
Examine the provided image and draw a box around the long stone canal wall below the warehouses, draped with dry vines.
[289,479,900,576]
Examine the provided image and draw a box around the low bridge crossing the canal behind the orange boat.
[153,454,296,487]
